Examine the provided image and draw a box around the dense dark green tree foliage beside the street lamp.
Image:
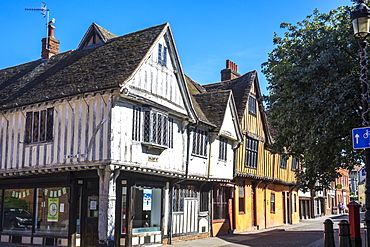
[262,6,362,190]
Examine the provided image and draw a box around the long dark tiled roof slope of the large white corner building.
[0,23,168,110]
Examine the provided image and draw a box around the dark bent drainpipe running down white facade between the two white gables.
[168,121,198,244]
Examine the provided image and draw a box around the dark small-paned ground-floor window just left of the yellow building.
[213,186,228,220]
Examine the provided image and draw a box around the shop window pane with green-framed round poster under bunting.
[36,187,70,234]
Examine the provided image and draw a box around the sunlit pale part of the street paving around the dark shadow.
[167,214,365,247]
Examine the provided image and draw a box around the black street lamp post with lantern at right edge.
[351,0,370,247]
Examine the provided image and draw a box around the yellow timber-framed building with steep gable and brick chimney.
[204,60,299,235]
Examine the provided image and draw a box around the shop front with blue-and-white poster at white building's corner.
[116,176,168,246]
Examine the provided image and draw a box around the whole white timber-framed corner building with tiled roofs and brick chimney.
[0,23,246,247]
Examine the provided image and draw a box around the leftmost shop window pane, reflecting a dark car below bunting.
[3,189,34,232]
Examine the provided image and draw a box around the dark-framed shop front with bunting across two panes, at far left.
[0,173,71,246]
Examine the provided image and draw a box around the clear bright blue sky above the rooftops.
[0,0,352,94]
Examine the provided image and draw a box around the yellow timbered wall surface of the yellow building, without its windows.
[234,80,299,232]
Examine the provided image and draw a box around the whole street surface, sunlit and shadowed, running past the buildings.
[168,214,365,247]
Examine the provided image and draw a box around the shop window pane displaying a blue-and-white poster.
[132,187,162,234]
